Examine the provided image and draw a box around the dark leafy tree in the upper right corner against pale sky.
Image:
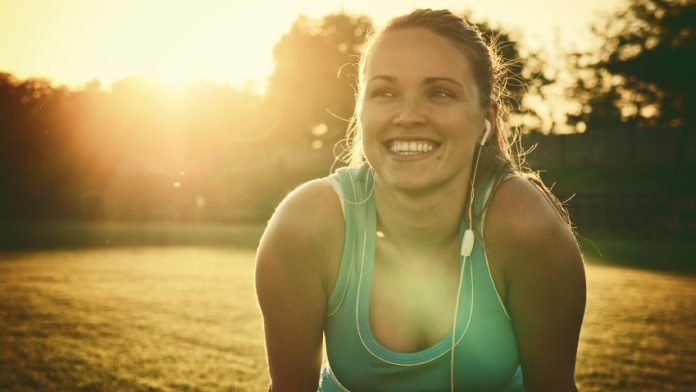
[568,0,696,129]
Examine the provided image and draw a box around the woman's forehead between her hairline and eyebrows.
[364,28,472,82]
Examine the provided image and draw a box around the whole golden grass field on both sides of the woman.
[0,247,696,391]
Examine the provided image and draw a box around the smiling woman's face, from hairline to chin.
[359,28,486,191]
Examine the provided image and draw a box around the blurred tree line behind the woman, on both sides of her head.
[0,0,696,219]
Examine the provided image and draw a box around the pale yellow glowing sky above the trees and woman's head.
[0,0,624,90]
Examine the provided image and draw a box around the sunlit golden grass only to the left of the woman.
[0,248,267,391]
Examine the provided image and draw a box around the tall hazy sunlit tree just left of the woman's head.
[267,14,372,151]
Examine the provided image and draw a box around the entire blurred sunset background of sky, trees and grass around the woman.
[0,0,696,390]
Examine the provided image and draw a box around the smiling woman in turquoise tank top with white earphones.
[256,10,585,392]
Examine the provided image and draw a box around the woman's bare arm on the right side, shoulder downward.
[487,179,585,391]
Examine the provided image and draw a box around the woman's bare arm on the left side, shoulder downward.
[256,181,343,391]
